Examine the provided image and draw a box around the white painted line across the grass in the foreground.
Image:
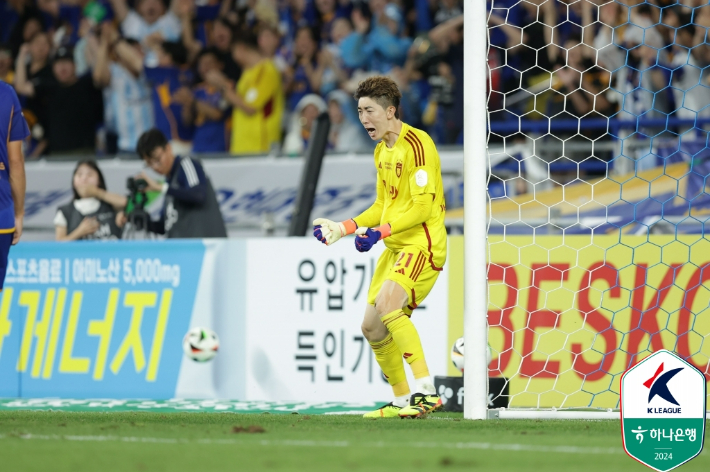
[0,434,624,454]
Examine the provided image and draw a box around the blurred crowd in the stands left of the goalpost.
[0,0,464,159]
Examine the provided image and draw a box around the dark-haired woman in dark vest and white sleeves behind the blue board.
[54,160,126,241]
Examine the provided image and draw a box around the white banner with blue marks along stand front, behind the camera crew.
[25,151,463,229]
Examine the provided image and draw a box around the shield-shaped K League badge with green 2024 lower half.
[621,349,706,472]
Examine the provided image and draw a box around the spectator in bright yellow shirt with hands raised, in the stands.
[207,34,284,154]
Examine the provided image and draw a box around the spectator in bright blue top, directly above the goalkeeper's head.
[341,3,412,73]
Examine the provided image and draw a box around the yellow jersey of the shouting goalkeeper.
[356,123,446,270]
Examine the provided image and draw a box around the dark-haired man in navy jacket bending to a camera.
[131,129,227,238]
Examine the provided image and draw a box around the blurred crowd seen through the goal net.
[489,0,710,153]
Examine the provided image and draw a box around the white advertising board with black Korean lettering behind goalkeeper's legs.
[245,238,450,402]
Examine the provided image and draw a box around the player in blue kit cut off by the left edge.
[0,82,30,289]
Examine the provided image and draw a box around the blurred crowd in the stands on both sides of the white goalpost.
[0,0,710,165]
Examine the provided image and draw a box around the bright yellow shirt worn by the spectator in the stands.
[230,59,284,154]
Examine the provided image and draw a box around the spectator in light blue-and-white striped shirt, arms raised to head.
[95,23,155,154]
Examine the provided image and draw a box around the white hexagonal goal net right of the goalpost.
[484,0,710,411]
